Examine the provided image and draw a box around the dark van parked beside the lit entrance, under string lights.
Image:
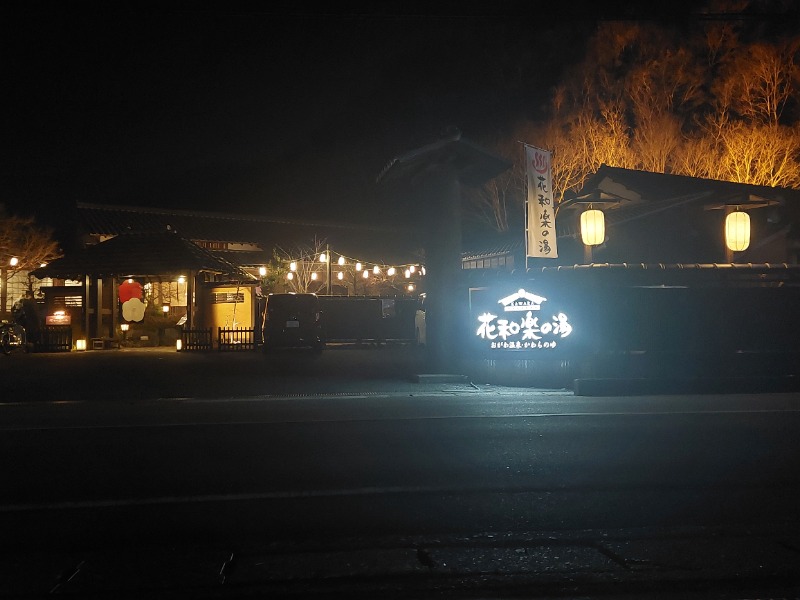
[264,293,325,352]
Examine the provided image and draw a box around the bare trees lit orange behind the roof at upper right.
[506,11,800,220]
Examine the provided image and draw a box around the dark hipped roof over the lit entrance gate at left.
[33,231,246,279]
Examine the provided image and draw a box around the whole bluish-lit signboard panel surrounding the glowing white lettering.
[469,282,579,358]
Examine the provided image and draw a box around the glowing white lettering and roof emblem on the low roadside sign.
[475,290,572,350]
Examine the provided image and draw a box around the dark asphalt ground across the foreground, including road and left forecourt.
[0,348,800,597]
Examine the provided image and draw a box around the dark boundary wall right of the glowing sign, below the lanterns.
[468,265,800,378]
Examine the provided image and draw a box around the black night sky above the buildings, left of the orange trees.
[0,1,712,241]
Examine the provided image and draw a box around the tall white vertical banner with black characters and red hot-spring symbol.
[525,145,558,258]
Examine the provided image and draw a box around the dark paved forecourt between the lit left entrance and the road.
[0,345,444,402]
